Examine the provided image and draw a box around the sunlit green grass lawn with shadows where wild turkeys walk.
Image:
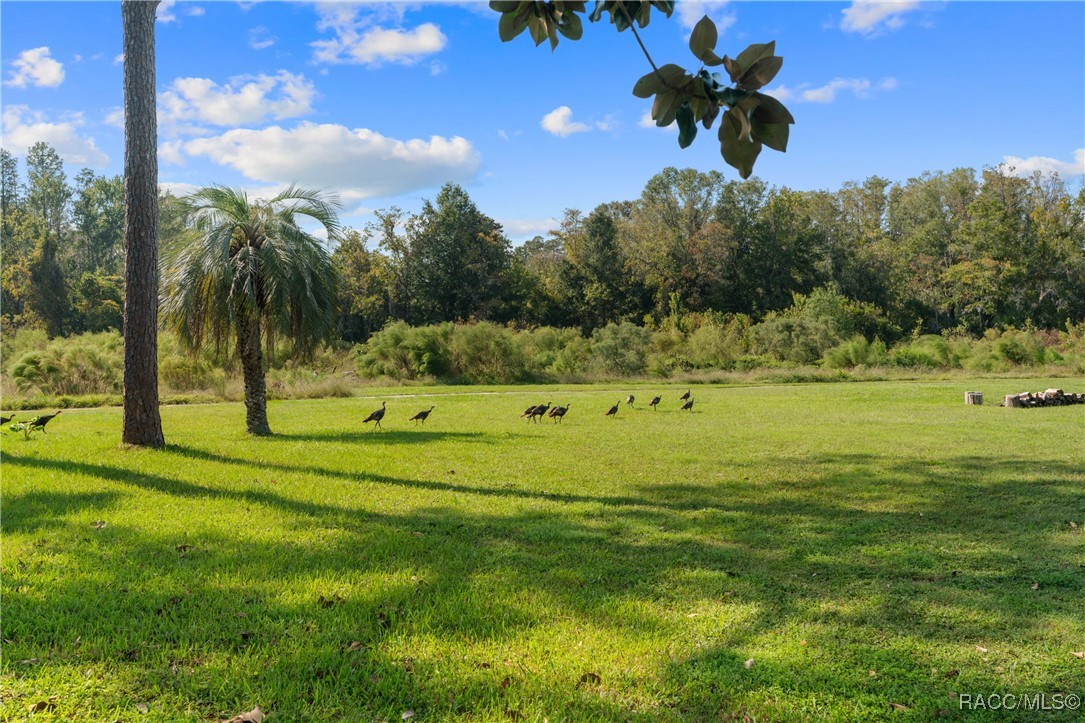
[0,379,1085,722]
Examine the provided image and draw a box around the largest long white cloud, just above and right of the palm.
[183,122,480,200]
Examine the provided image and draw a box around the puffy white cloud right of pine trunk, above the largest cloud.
[158,71,317,126]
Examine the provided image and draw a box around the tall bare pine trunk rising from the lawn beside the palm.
[120,0,166,447]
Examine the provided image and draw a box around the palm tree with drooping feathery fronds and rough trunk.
[162,186,340,434]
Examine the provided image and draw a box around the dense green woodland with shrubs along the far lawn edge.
[0,143,1085,397]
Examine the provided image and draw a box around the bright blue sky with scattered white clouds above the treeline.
[0,0,1085,240]
